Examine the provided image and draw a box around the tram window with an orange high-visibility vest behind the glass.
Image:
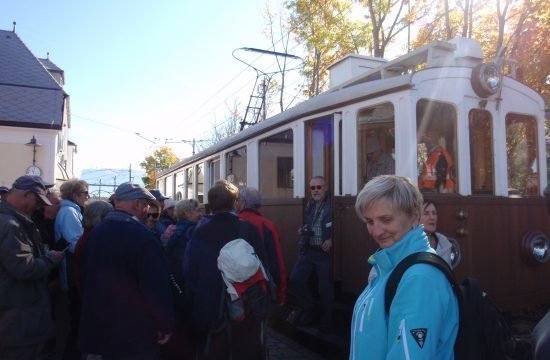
[416,99,458,193]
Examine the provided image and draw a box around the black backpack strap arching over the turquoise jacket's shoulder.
[384,252,461,315]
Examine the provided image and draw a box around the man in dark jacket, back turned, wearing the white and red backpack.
[183,180,267,360]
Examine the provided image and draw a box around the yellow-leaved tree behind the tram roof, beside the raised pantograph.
[286,0,369,97]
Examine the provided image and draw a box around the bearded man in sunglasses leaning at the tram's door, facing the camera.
[288,176,334,332]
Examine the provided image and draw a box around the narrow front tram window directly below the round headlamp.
[468,109,494,194]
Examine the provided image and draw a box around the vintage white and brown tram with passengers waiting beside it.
[157,38,550,310]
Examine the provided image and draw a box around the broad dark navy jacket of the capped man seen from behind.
[79,210,175,358]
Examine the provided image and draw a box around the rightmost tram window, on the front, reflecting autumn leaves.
[506,114,540,196]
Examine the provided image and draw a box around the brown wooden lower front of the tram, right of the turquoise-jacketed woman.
[424,196,550,309]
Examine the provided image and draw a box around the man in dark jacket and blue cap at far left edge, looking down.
[0,175,64,359]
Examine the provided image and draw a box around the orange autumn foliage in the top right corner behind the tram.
[413,0,550,98]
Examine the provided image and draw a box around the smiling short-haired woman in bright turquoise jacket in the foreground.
[350,175,458,360]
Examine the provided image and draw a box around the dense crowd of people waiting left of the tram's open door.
[0,176,294,360]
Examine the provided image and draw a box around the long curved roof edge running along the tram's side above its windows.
[159,74,412,177]
